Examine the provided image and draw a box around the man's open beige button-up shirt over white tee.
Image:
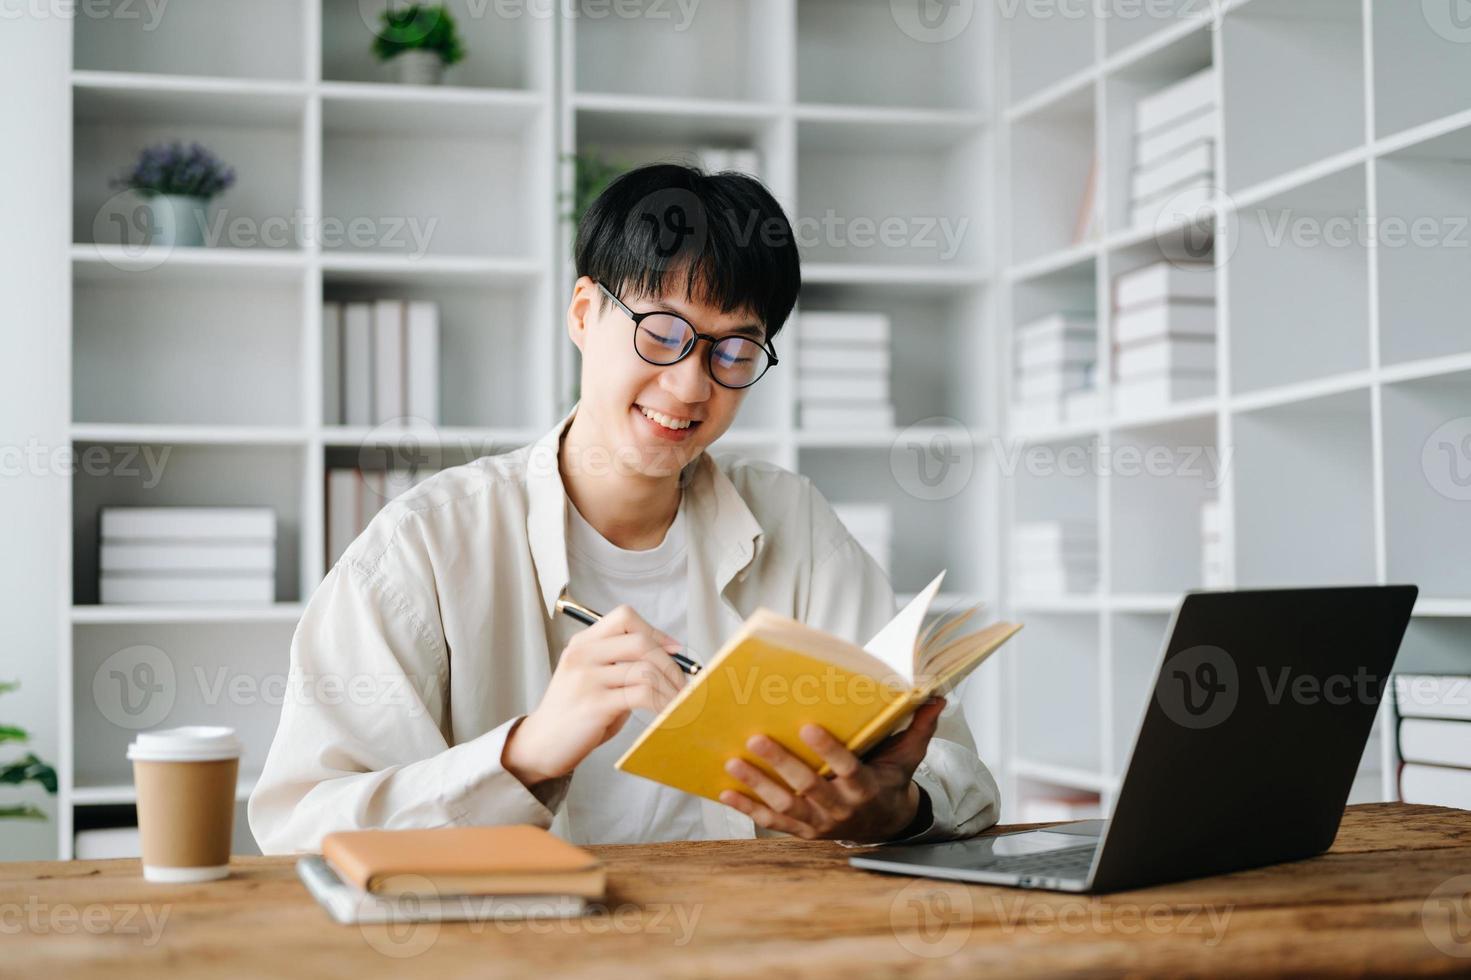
[249,406,999,853]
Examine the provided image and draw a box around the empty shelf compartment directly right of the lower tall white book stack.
[1218,166,1370,394]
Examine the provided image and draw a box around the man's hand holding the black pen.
[500,605,684,787]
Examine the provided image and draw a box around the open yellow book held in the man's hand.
[618,572,1021,800]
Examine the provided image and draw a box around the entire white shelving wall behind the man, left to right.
[37,0,1471,856]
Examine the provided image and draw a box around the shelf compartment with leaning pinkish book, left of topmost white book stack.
[1011,85,1100,265]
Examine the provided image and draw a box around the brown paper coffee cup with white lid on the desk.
[128,725,240,881]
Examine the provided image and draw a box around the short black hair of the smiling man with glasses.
[575,163,802,343]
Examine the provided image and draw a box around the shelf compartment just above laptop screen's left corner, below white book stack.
[1109,415,1228,593]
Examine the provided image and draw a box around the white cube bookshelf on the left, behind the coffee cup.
[57,0,559,856]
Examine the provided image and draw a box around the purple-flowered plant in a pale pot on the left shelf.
[112,141,235,247]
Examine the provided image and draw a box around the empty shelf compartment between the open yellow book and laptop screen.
[1009,614,1105,789]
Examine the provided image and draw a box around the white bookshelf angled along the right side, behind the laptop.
[994,0,1471,814]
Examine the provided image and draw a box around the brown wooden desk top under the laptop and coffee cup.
[0,803,1471,980]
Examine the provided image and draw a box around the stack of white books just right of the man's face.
[797,310,894,430]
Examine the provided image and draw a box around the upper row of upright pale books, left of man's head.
[322,299,440,425]
